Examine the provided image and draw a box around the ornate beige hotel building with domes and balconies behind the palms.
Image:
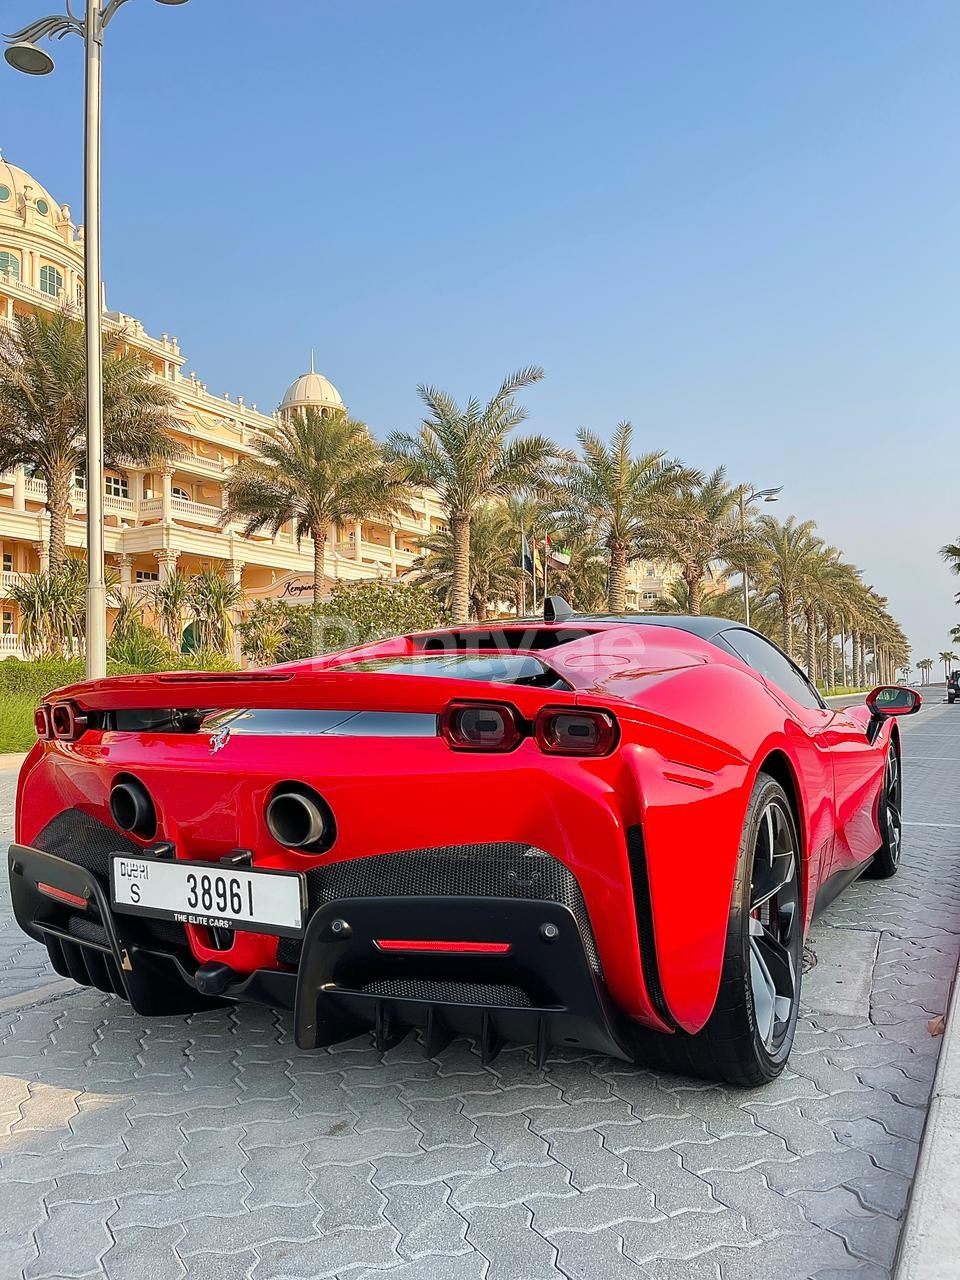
[0,160,444,657]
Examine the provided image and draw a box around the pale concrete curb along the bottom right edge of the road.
[893,957,960,1280]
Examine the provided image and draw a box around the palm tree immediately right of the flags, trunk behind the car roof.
[564,421,700,613]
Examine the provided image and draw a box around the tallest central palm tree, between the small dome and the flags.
[388,365,558,623]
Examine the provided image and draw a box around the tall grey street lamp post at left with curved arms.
[4,0,186,680]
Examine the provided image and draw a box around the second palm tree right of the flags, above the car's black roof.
[646,467,746,614]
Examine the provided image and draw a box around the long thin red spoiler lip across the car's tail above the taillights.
[44,669,580,716]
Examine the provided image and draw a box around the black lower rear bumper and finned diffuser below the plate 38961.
[8,837,632,1061]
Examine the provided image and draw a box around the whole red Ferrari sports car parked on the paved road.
[9,599,920,1085]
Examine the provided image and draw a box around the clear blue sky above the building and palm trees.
[0,0,960,658]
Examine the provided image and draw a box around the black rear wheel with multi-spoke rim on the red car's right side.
[644,773,803,1088]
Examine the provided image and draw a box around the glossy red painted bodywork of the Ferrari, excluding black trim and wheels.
[17,620,911,1030]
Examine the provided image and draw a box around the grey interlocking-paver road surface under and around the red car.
[0,690,960,1280]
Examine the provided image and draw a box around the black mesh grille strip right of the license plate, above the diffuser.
[278,842,600,973]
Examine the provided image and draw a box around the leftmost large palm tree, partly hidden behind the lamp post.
[0,311,180,568]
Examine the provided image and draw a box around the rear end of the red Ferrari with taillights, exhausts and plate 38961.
[10,628,706,1057]
